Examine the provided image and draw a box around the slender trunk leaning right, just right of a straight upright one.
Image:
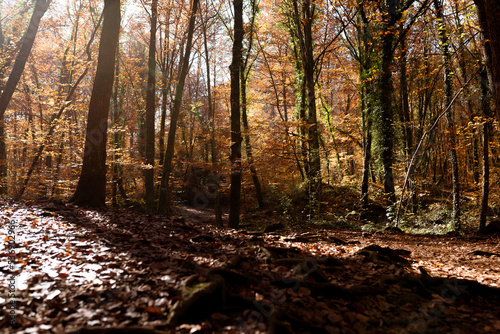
[158,0,199,214]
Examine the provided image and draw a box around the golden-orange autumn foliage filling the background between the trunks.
[0,0,500,234]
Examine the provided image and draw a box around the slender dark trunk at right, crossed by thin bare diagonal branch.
[434,0,460,229]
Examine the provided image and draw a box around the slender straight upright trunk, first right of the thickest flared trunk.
[144,0,158,214]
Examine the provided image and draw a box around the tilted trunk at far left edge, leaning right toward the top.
[0,0,51,194]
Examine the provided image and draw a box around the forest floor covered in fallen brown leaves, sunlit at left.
[0,201,500,334]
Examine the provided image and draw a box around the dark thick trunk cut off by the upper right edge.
[474,0,500,120]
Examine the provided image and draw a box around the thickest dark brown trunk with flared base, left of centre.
[70,0,121,207]
